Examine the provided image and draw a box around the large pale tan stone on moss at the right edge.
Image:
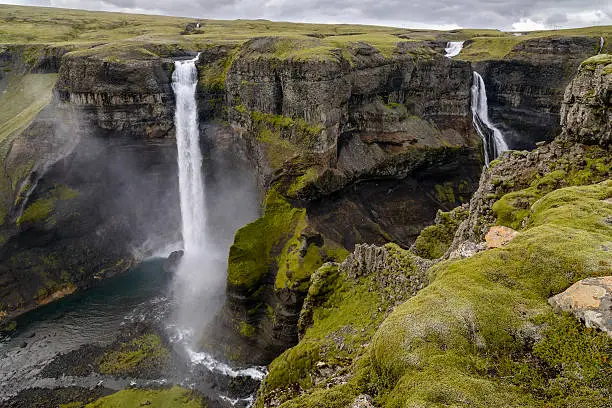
[548,276,612,337]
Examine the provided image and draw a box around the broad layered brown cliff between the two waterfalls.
[226,38,480,187]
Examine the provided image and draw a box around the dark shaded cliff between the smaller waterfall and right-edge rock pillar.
[475,37,599,150]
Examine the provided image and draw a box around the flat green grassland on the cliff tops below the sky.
[0,5,612,61]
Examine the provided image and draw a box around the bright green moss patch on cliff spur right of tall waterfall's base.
[228,189,305,293]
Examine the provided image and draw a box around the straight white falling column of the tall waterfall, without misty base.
[172,57,206,254]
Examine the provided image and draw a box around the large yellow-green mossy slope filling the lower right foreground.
[260,181,612,407]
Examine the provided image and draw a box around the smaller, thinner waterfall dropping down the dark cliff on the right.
[472,71,508,166]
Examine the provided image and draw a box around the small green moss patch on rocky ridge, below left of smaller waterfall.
[412,207,468,259]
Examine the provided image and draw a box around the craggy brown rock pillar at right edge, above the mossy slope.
[561,54,612,146]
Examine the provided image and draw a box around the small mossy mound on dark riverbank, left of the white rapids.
[100,334,169,375]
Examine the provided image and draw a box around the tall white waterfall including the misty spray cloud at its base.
[172,53,227,334]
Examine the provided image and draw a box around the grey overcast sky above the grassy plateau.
[4,0,612,30]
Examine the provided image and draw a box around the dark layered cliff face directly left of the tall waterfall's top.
[56,52,174,138]
